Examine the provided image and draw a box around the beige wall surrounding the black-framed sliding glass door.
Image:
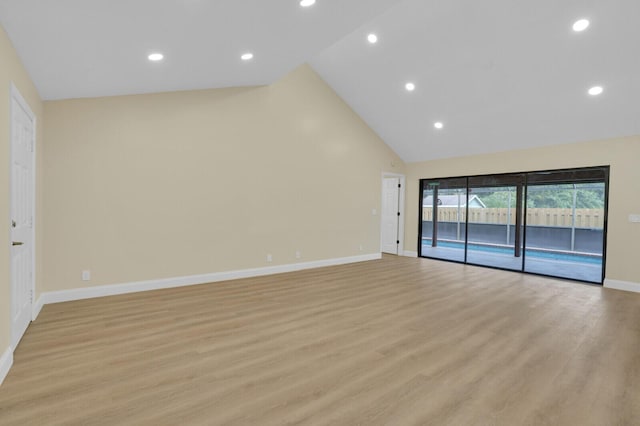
[405,136,640,283]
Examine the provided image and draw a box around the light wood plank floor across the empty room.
[0,256,640,425]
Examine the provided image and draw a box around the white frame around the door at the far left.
[7,82,38,344]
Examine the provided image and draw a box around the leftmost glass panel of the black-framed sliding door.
[420,178,467,262]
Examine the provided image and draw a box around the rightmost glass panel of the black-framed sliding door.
[525,182,605,283]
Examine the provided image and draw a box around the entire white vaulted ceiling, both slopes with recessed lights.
[0,0,640,162]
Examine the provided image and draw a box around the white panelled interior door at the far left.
[10,89,35,348]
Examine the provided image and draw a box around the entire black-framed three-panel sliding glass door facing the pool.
[418,166,609,283]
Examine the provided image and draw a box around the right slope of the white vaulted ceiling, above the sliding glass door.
[311,0,640,162]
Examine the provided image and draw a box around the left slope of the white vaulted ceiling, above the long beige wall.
[0,0,398,100]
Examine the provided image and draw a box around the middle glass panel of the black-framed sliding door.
[467,184,522,271]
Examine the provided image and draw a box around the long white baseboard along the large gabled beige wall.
[38,253,382,305]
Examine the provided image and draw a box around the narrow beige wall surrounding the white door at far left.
[0,27,43,355]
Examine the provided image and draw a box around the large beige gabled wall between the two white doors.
[44,66,404,291]
